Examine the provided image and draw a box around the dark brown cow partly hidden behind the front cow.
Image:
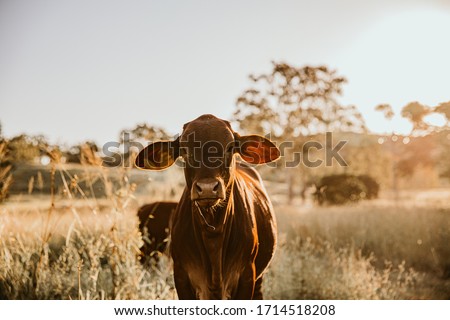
[138,202,178,263]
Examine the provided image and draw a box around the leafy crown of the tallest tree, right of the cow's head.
[234,62,365,138]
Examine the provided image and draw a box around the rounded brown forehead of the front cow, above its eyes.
[180,115,234,143]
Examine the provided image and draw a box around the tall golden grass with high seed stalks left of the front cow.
[0,148,174,299]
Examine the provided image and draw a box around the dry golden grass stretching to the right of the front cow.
[266,202,450,299]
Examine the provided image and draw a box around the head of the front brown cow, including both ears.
[136,115,280,208]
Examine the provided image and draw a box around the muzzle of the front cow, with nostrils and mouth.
[191,178,225,207]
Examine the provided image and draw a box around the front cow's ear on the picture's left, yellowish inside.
[134,139,180,170]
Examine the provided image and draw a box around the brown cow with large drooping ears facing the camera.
[136,115,280,299]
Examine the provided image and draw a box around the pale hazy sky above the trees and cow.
[0,0,450,143]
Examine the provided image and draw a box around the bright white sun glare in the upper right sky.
[341,10,450,133]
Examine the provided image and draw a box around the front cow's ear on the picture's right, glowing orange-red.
[235,134,280,164]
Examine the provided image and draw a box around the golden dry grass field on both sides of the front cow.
[0,164,450,299]
